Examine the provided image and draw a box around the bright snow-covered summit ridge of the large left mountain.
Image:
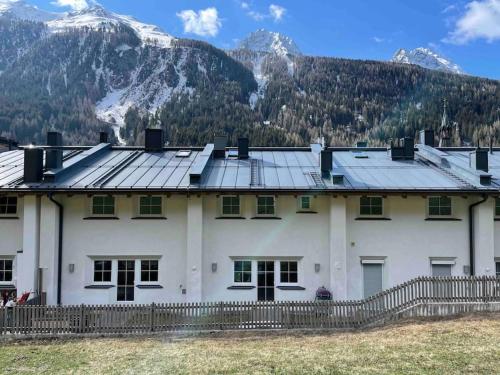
[47,5,175,48]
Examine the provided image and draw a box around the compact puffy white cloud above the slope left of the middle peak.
[177,8,222,37]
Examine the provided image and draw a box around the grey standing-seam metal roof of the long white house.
[0,144,500,193]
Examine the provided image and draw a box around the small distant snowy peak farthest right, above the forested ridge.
[392,47,464,74]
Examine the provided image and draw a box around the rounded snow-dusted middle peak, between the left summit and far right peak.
[237,29,301,56]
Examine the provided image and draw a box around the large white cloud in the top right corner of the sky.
[443,0,500,44]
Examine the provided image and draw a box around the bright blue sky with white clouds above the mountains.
[28,0,500,79]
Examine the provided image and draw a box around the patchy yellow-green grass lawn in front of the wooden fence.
[0,315,500,374]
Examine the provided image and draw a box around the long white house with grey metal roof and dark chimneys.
[0,129,500,304]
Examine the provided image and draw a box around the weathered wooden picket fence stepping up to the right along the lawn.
[0,277,500,335]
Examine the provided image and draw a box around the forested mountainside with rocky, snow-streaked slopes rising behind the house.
[0,0,500,146]
